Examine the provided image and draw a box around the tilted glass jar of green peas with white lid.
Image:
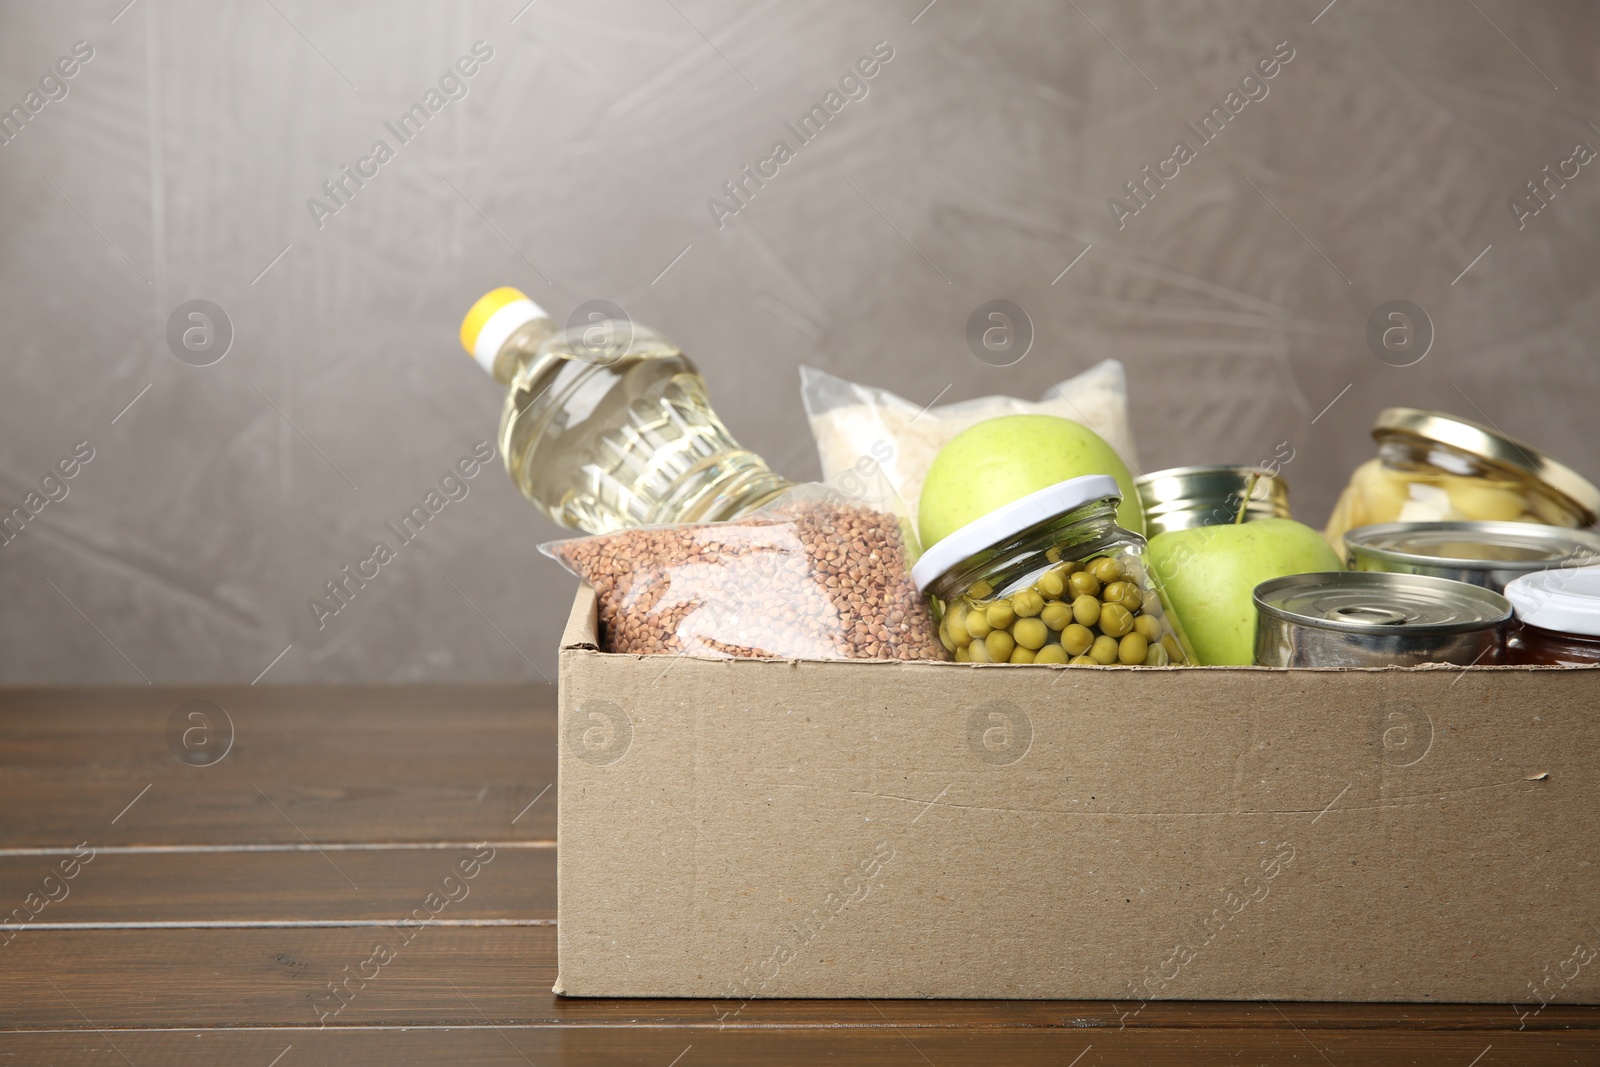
[912,475,1194,667]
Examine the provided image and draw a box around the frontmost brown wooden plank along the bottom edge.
[0,1024,1597,1067]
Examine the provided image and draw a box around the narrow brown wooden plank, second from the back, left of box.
[0,841,555,939]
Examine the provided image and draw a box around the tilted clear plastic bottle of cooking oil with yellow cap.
[461,288,794,533]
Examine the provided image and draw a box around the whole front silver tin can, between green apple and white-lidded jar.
[1254,571,1510,667]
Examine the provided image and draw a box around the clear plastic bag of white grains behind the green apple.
[800,360,1139,531]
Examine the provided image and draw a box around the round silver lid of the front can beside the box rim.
[1254,571,1510,637]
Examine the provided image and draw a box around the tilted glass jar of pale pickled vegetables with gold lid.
[1323,408,1600,555]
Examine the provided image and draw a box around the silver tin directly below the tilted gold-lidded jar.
[1344,522,1600,592]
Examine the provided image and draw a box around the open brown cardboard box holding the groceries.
[555,589,1600,1013]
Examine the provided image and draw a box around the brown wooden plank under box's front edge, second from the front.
[0,926,1600,1049]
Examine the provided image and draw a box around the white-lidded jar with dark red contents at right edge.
[1506,566,1600,667]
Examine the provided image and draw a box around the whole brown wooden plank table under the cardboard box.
[0,686,1600,1067]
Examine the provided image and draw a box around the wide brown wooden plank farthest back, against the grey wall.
[0,686,555,848]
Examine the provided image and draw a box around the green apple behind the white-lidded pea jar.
[917,414,1144,547]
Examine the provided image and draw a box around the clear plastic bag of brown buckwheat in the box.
[539,483,949,659]
